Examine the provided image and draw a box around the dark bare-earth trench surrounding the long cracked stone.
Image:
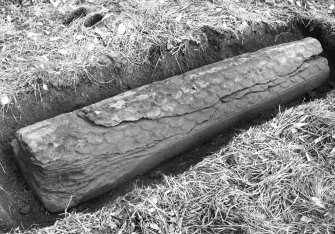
[0,19,335,230]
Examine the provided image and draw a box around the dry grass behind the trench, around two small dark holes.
[0,0,334,101]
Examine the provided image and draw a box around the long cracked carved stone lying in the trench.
[12,38,329,211]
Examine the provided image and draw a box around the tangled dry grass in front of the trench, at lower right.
[15,92,335,234]
